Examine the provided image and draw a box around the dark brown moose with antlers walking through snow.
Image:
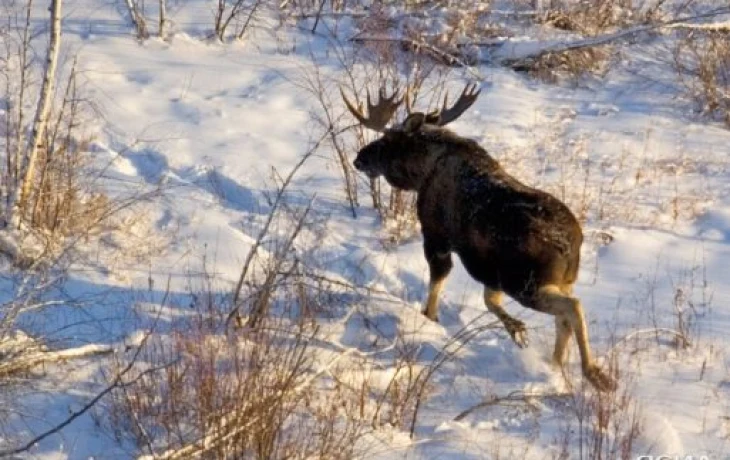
[340,84,616,391]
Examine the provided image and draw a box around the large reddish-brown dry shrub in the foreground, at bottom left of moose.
[103,288,366,459]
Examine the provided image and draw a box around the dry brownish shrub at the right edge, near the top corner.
[673,29,730,127]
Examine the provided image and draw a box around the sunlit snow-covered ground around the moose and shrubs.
[1,0,730,459]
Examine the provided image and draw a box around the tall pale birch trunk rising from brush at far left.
[12,0,62,224]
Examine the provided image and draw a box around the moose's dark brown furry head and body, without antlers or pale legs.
[356,119,583,310]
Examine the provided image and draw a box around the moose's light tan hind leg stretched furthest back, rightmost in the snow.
[538,285,616,391]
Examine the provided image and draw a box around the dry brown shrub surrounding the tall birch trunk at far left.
[0,2,126,246]
